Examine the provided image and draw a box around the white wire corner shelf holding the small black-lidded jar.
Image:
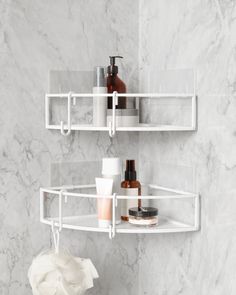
[40,185,200,238]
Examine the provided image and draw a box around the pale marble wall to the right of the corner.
[139,0,236,295]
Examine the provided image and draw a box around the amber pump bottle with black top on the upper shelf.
[107,55,126,109]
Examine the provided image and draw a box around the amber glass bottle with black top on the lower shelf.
[121,160,141,221]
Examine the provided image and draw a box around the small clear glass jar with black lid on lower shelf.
[129,207,158,226]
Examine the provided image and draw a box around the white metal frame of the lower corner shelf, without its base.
[40,184,200,239]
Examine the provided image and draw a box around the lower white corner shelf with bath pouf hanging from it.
[40,184,200,238]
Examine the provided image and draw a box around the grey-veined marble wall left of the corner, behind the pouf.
[0,0,139,295]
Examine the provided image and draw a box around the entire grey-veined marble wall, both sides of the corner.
[0,0,236,295]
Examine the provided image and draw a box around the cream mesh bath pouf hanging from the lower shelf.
[28,251,98,295]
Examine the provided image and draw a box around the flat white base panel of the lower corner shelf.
[42,214,198,234]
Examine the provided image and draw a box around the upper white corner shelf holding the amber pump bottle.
[45,92,197,137]
